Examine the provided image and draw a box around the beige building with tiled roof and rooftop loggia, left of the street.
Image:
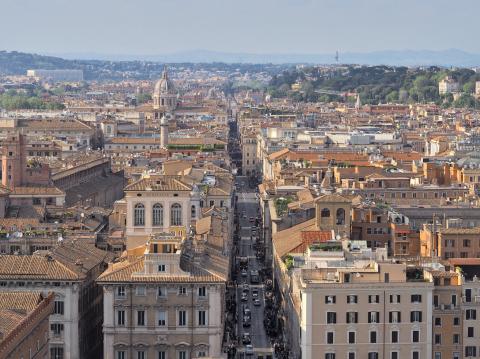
[98,233,229,359]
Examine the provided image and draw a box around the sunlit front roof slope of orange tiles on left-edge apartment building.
[0,255,80,281]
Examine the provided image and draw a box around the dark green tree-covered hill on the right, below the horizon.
[268,66,480,107]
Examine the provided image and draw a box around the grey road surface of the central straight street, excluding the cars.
[237,176,272,357]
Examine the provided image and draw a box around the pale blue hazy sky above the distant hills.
[0,0,480,55]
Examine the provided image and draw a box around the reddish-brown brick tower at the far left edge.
[2,134,26,188]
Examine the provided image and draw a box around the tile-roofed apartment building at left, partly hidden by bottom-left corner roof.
[0,240,112,359]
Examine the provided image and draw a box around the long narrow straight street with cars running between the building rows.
[236,176,272,358]
